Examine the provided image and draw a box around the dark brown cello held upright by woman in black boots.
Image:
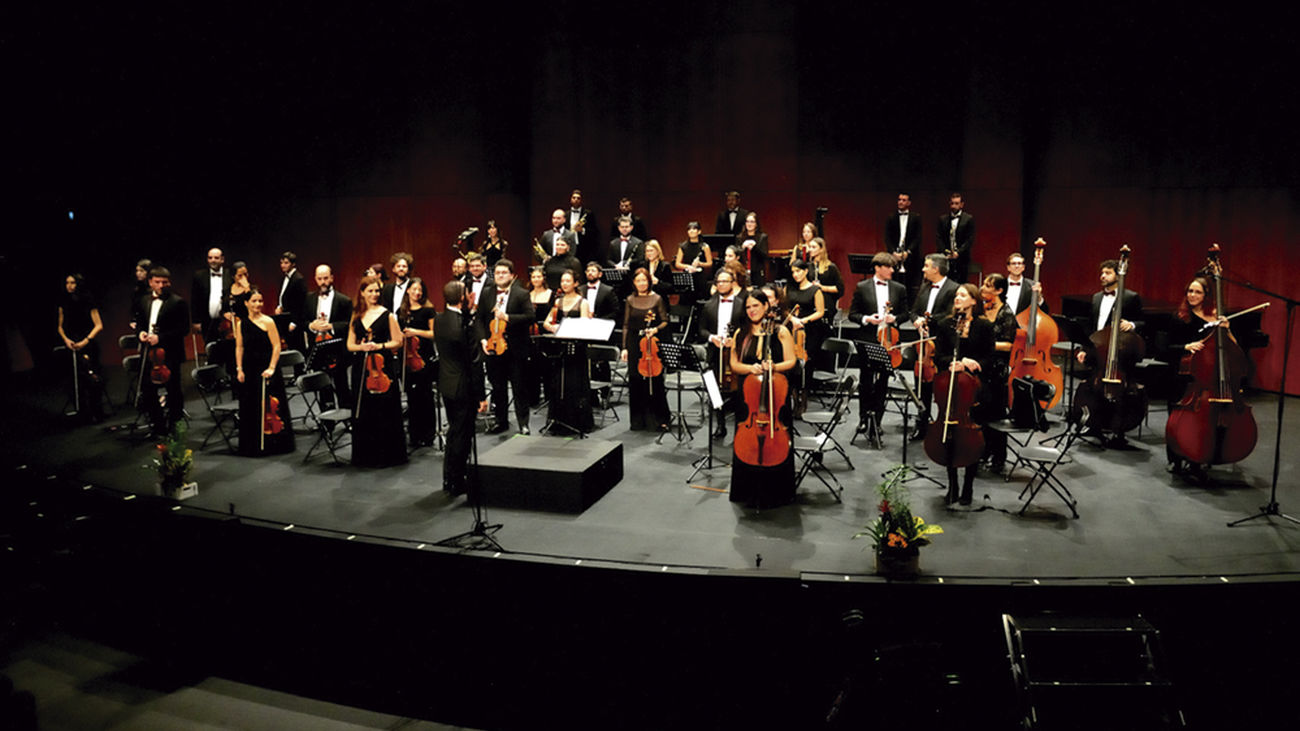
[926,312,984,468]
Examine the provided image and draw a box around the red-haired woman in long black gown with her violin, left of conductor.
[347,277,407,467]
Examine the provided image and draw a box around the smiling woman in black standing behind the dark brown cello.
[930,282,987,505]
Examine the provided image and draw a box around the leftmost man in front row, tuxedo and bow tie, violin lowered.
[137,270,189,438]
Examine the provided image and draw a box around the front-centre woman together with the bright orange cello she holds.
[731,290,796,509]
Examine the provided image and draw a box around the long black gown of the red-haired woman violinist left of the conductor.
[352,310,407,467]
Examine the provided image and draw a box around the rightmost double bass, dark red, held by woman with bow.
[1165,243,1258,464]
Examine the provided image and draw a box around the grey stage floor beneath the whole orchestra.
[4,369,1300,580]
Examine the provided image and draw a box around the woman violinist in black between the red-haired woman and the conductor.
[398,277,438,449]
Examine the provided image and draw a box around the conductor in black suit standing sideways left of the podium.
[433,280,488,494]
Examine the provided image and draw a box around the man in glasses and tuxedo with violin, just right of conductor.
[475,259,534,434]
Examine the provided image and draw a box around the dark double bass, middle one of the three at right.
[1074,245,1148,434]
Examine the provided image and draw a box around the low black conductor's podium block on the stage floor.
[478,436,623,512]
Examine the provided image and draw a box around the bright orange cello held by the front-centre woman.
[733,320,790,466]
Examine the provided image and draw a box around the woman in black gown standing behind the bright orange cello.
[731,290,796,507]
